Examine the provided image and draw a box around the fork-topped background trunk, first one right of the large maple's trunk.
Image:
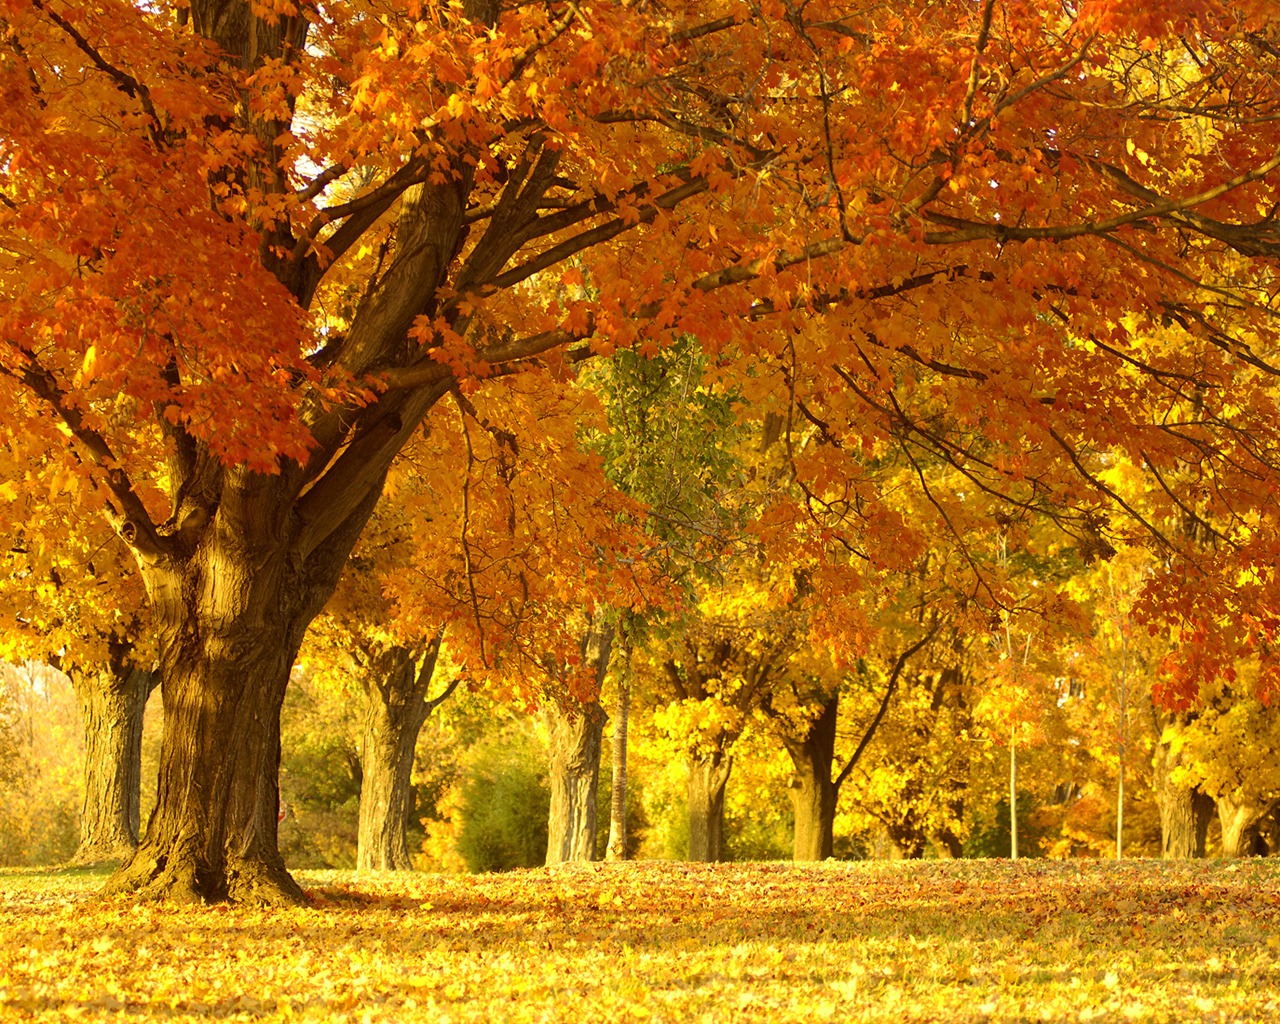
[356,636,456,870]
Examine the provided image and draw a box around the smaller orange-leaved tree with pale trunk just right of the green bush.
[364,378,667,863]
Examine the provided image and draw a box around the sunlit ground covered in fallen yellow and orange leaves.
[0,861,1280,1024]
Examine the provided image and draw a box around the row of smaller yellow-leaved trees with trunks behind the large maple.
[15,339,1280,869]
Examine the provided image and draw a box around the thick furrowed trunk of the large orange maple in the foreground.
[105,483,379,905]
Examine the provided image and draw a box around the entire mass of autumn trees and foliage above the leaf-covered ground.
[0,0,1280,904]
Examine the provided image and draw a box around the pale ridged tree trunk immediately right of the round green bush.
[547,621,613,864]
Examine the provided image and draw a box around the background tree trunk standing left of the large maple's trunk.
[70,643,156,864]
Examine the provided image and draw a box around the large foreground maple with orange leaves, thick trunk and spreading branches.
[0,0,1280,901]
